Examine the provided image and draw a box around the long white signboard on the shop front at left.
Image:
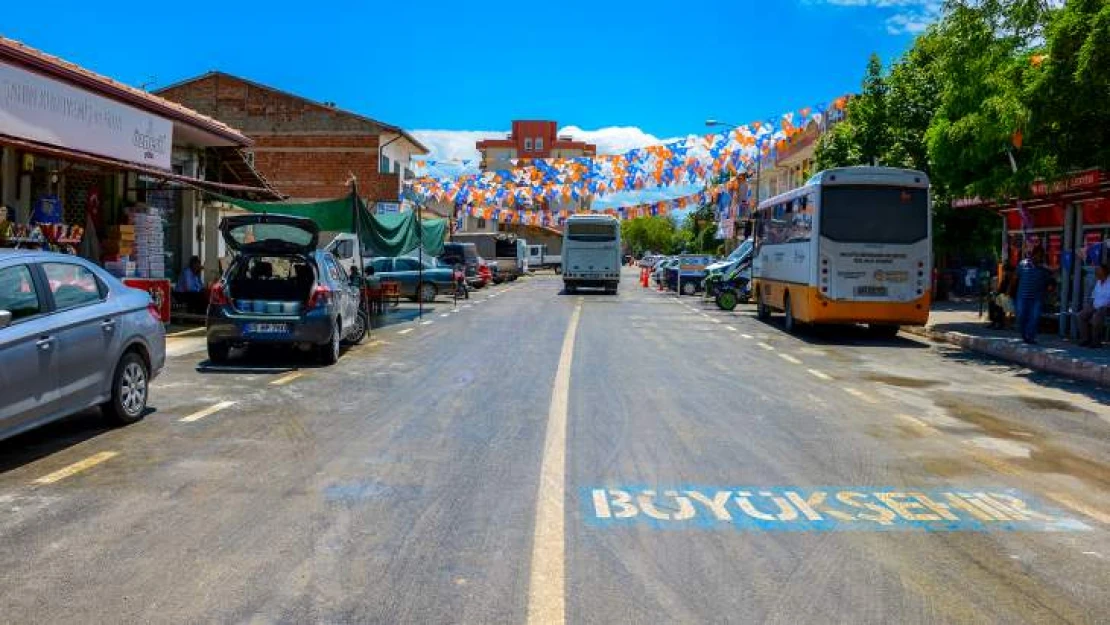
[0,62,173,170]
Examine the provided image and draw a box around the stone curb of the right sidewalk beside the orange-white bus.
[902,326,1110,387]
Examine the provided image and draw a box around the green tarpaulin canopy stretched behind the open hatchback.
[209,194,447,256]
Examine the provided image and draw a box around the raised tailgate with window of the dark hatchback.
[220,213,320,254]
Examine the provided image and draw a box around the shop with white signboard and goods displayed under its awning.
[0,38,279,319]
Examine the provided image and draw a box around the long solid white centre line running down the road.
[528,301,582,625]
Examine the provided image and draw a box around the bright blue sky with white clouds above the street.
[0,0,937,164]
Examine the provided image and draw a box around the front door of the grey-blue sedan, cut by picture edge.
[0,264,60,437]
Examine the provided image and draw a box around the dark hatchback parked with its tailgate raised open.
[208,214,369,364]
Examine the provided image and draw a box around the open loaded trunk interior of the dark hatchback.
[228,255,316,315]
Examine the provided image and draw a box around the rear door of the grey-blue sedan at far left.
[40,261,121,411]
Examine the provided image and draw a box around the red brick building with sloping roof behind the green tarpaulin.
[157,72,427,202]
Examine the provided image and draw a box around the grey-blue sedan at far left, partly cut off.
[0,250,165,440]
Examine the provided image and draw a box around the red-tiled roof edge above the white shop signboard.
[0,36,254,147]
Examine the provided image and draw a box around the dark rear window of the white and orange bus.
[821,184,929,243]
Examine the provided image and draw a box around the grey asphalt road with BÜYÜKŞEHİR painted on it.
[0,272,1110,624]
